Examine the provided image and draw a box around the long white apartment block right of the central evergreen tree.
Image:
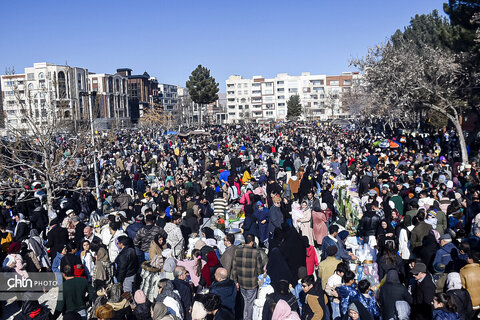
[226,72,359,123]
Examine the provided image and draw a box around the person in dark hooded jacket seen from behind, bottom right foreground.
[377,269,413,319]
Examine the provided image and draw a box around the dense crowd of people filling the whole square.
[0,123,480,320]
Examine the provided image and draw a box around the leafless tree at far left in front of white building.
[0,69,93,210]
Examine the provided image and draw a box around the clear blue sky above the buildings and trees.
[0,0,444,91]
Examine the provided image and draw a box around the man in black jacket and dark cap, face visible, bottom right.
[411,262,435,320]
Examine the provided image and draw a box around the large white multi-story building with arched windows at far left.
[1,62,88,132]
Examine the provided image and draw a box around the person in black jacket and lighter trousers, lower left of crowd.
[115,236,138,292]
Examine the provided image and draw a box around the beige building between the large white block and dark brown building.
[88,73,130,128]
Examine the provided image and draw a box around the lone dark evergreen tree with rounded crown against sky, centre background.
[186,64,218,124]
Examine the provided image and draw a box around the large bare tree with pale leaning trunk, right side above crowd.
[351,42,468,163]
